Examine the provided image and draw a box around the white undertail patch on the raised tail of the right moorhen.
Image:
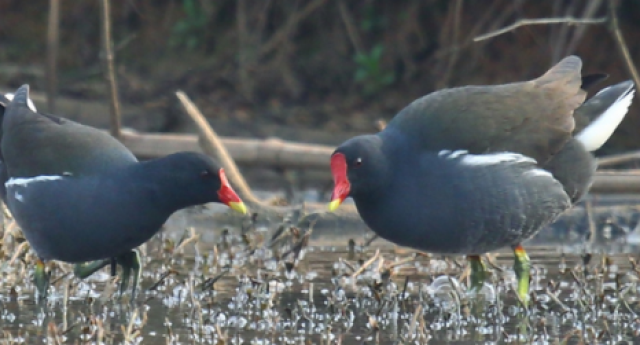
[575,90,636,152]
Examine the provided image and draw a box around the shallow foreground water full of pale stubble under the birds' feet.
[0,192,640,344]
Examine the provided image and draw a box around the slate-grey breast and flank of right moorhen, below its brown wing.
[345,131,571,255]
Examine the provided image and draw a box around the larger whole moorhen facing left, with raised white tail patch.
[329,56,635,302]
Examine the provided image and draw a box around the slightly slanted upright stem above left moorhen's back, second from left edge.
[100,0,121,138]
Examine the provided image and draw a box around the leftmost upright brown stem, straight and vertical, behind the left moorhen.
[46,0,60,113]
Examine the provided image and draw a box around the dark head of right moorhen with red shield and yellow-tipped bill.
[329,135,390,211]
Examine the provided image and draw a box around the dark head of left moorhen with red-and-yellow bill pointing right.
[143,152,247,214]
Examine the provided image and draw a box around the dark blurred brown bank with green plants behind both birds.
[0,0,640,158]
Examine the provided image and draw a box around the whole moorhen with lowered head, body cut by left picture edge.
[0,85,246,300]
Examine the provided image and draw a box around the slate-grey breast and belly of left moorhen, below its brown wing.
[7,153,219,263]
